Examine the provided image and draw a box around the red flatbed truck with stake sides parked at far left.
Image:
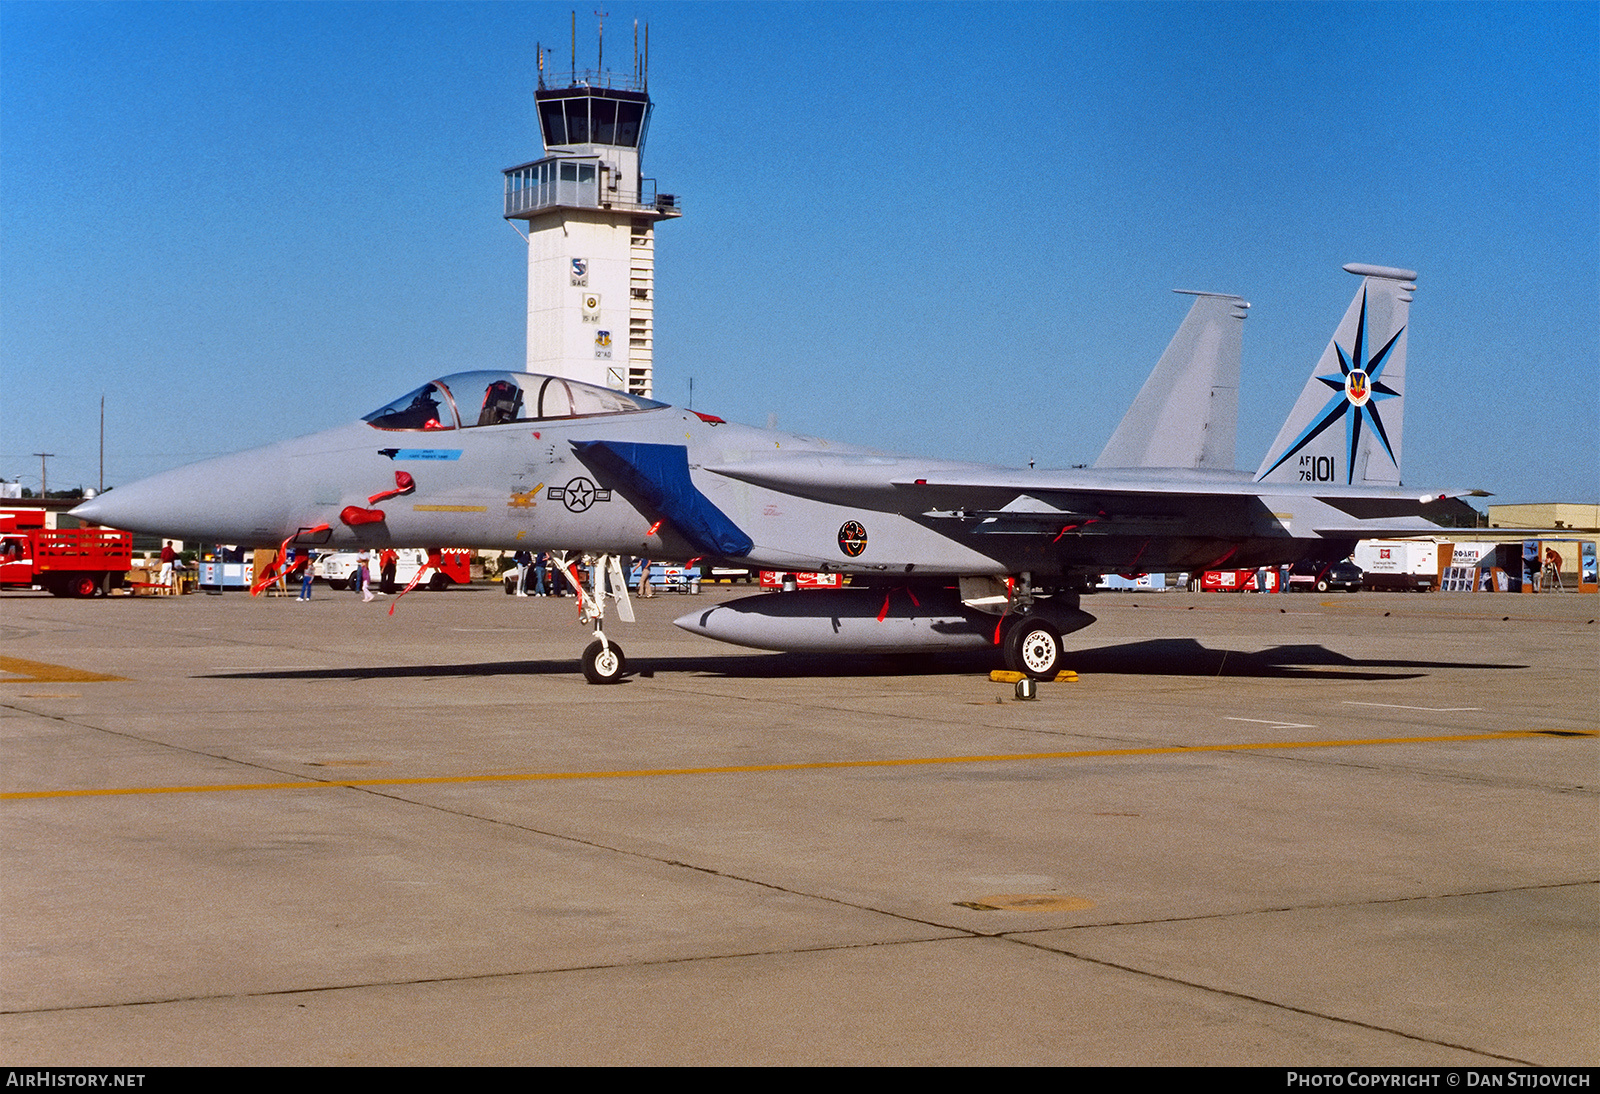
[0,510,133,597]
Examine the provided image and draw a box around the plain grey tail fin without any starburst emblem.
[1094,289,1250,470]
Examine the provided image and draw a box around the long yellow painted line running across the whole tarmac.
[0,729,1600,801]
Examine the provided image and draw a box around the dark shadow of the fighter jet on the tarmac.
[202,638,1526,680]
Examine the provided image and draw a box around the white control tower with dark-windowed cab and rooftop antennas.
[504,16,682,395]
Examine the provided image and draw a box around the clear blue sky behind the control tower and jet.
[0,2,1600,502]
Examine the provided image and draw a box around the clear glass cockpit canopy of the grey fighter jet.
[362,373,666,430]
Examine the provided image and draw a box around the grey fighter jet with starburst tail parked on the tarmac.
[74,264,1475,683]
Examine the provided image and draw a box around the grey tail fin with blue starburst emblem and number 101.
[1256,262,1416,486]
